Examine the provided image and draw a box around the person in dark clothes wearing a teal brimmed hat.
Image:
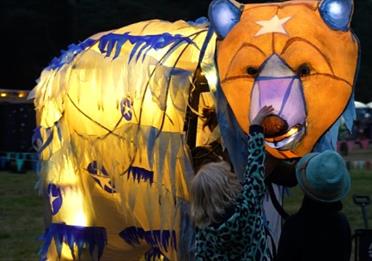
[274,150,351,261]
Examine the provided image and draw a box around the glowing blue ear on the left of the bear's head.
[208,0,241,38]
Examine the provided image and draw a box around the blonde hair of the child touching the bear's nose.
[190,161,241,227]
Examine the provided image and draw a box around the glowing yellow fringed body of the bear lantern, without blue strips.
[33,21,217,260]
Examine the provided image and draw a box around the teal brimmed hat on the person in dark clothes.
[296,150,351,202]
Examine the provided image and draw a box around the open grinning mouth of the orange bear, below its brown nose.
[265,124,306,151]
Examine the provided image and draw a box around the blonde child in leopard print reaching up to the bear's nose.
[191,106,273,261]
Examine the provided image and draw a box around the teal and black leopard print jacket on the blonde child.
[195,126,270,261]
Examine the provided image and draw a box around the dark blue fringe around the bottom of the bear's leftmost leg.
[39,223,107,260]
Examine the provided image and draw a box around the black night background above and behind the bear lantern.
[0,0,372,102]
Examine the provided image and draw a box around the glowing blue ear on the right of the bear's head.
[319,0,354,31]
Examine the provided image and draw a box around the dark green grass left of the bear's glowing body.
[0,172,43,261]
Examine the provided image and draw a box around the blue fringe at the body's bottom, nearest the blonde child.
[119,224,177,260]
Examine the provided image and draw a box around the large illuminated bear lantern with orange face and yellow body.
[33,0,358,260]
